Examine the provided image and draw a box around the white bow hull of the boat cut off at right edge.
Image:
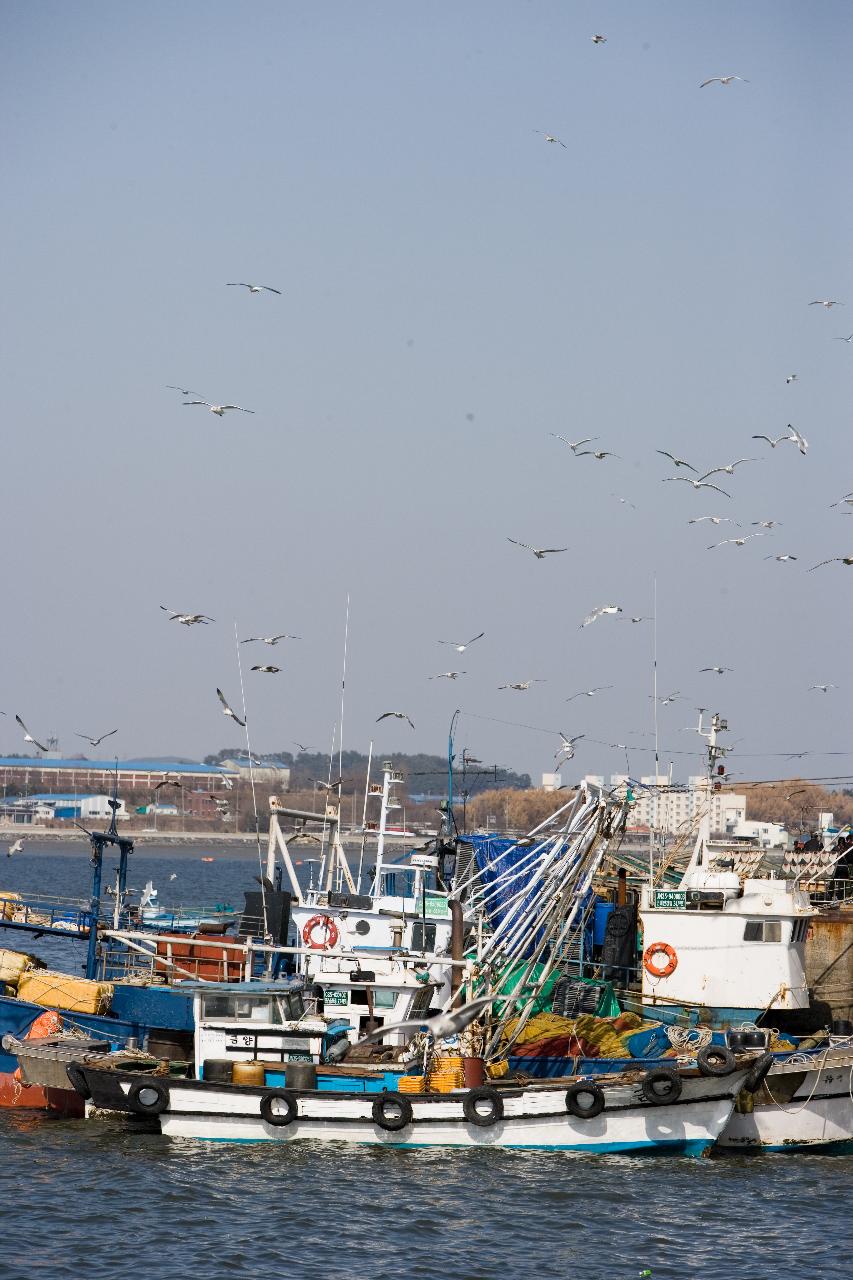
[717,1043,853,1151]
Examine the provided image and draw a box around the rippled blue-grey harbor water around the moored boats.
[0,845,853,1280]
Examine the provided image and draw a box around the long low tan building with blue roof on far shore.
[0,755,240,792]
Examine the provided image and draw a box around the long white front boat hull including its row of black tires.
[76,1064,749,1156]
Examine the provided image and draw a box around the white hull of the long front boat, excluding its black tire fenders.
[82,1066,747,1155]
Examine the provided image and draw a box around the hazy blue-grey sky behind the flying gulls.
[0,0,853,781]
